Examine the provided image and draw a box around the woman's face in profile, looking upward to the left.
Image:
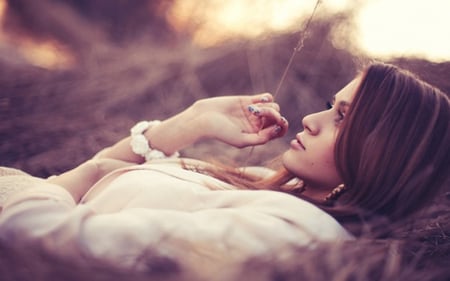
[283,78,360,189]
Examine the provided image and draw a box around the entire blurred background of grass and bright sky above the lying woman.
[0,0,450,177]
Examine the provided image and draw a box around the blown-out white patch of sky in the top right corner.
[358,0,450,61]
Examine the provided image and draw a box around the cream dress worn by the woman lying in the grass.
[0,160,352,279]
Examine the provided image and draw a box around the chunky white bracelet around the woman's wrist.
[130,120,180,161]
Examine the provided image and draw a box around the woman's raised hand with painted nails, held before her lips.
[190,93,288,147]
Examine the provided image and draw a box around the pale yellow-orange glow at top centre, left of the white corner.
[169,0,349,46]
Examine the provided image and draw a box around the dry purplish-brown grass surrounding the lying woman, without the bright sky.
[0,1,450,280]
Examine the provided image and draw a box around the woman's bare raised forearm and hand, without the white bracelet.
[96,93,288,163]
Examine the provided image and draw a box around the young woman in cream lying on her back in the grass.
[0,61,450,276]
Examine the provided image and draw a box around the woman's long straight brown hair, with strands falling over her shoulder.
[185,63,450,232]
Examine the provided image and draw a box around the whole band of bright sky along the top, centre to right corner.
[174,0,450,61]
